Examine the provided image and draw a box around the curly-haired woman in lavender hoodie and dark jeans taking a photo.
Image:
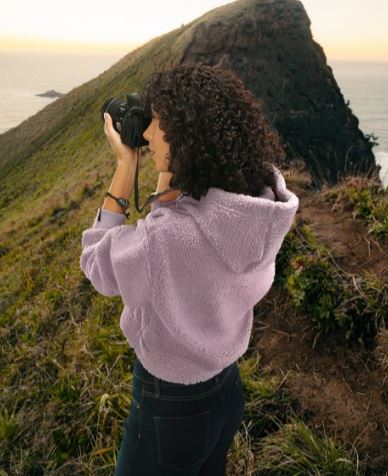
[80,64,299,476]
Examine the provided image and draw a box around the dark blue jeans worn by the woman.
[114,359,245,476]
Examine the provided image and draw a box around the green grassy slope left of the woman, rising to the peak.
[0,18,200,474]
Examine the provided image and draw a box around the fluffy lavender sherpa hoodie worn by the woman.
[80,167,299,384]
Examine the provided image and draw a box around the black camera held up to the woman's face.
[101,93,152,149]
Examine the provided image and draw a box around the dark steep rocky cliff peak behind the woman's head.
[182,0,378,185]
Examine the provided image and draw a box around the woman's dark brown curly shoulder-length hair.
[141,63,285,200]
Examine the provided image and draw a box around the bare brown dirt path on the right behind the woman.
[247,174,388,475]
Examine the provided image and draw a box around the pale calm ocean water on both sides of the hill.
[0,51,388,186]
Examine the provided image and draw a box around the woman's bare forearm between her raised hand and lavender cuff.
[102,160,136,213]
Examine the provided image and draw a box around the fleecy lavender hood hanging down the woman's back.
[177,166,299,272]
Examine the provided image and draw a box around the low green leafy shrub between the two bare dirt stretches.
[287,255,388,343]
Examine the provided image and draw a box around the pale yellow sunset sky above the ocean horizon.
[0,0,388,61]
